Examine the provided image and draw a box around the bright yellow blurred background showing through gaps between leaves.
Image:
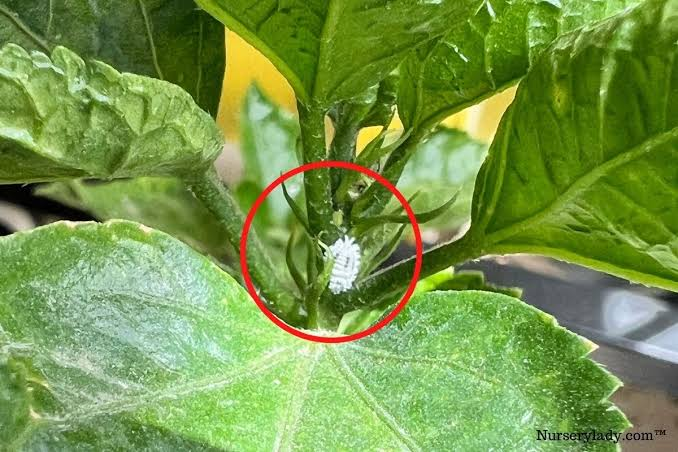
[218,31,515,147]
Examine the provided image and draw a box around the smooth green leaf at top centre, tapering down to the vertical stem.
[197,0,482,106]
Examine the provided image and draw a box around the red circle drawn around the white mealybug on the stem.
[240,160,423,343]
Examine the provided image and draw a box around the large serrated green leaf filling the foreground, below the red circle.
[0,222,628,451]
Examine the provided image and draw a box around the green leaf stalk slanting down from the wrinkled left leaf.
[188,168,305,325]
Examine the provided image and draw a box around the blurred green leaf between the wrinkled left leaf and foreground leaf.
[36,177,232,258]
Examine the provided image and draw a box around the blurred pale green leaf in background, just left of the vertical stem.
[240,85,301,226]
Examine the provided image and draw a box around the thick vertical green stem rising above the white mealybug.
[298,103,334,236]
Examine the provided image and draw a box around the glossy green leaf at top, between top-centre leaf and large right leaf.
[398,0,639,128]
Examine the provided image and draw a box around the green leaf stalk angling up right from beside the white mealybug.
[333,234,482,313]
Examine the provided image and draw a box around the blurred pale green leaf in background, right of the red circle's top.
[398,127,487,231]
